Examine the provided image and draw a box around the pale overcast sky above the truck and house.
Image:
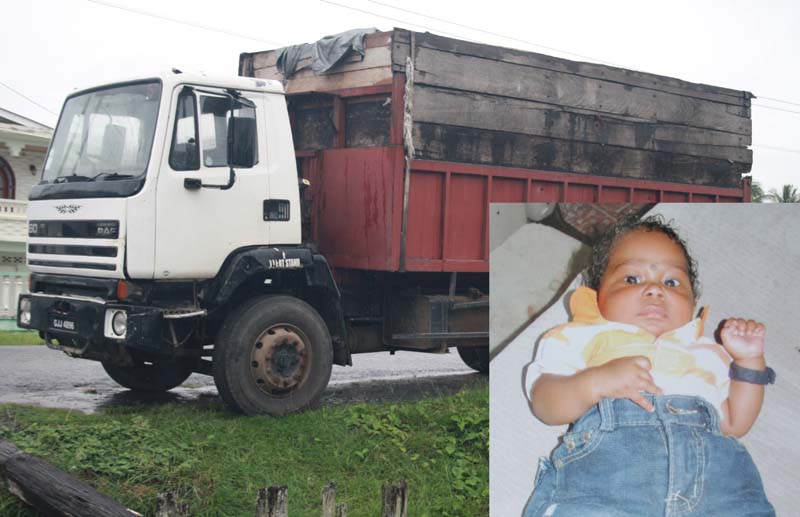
[0,0,800,190]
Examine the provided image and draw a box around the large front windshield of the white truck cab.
[42,81,161,183]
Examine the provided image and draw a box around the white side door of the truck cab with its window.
[155,86,269,279]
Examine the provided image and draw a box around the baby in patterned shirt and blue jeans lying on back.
[525,218,775,517]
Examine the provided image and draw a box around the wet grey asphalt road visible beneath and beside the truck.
[0,346,488,413]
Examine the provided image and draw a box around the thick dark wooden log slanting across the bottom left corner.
[0,439,136,517]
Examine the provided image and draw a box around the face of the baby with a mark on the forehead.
[597,230,694,336]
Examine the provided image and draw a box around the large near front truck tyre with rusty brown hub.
[213,296,333,415]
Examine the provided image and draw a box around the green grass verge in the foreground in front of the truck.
[0,384,489,517]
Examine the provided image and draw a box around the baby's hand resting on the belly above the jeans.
[589,355,663,411]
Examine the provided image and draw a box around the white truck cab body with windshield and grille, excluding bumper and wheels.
[28,73,300,280]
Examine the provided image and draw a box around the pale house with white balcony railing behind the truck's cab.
[0,108,53,330]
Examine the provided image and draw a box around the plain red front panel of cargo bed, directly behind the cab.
[311,147,403,271]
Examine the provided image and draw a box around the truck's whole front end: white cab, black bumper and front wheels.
[17,70,350,414]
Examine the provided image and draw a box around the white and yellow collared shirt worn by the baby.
[525,287,732,416]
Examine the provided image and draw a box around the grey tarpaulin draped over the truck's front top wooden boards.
[277,29,378,77]
